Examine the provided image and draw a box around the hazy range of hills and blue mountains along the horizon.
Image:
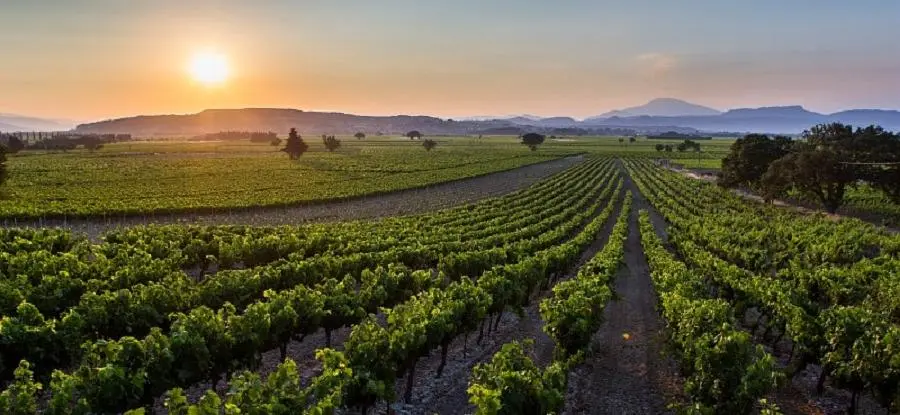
[8,98,900,136]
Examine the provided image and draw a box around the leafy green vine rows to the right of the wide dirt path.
[628,157,900,413]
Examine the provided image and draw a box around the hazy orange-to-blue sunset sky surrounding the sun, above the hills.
[0,0,900,120]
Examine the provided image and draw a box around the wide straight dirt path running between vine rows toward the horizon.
[564,162,682,414]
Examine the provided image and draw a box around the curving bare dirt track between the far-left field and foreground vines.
[10,155,584,239]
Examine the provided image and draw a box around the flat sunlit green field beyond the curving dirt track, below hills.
[0,137,584,218]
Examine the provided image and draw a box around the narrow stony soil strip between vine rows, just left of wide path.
[394,189,622,415]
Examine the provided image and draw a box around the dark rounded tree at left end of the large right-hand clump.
[717,134,792,190]
